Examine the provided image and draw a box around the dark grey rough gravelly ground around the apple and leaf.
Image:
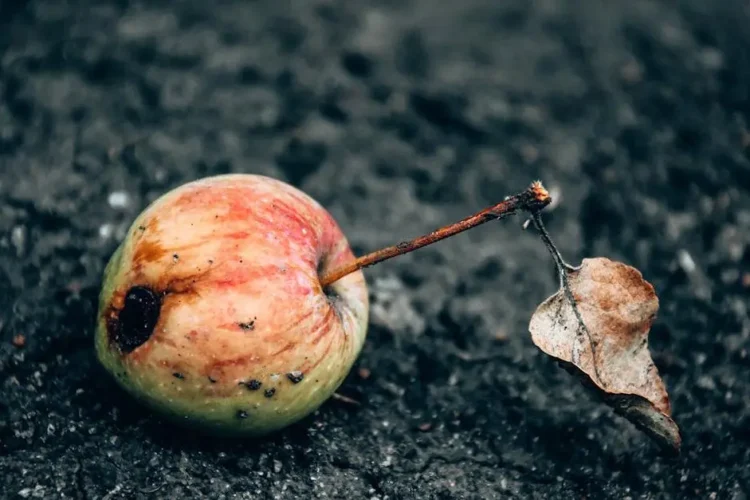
[0,0,750,500]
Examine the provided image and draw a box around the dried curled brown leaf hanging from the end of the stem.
[529,258,681,451]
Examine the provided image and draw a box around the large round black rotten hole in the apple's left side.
[107,286,161,353]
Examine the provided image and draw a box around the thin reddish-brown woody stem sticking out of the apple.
[320,181,552,288]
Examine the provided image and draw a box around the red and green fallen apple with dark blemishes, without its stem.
[95,174,369,436]
